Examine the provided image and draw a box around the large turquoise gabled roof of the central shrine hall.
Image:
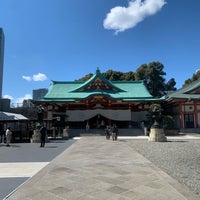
[39,69,156,102]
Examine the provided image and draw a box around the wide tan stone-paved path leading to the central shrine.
[7,136,199,200]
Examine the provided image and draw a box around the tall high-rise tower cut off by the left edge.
[0,28,5,98]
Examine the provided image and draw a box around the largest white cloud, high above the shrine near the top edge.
[103,0,166,34]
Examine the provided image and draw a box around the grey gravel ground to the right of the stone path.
[126,140,200,195]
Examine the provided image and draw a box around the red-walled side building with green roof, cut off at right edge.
[163,80,200,132]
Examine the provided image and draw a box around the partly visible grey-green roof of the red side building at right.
[163,80,200,101]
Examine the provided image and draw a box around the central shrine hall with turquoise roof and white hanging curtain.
[33,69,163,129]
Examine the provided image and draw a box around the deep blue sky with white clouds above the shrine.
[0,0,200,103]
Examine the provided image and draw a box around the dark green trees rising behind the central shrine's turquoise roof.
[76,62,176,97]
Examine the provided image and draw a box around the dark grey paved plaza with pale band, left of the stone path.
[0,140,74,199]
